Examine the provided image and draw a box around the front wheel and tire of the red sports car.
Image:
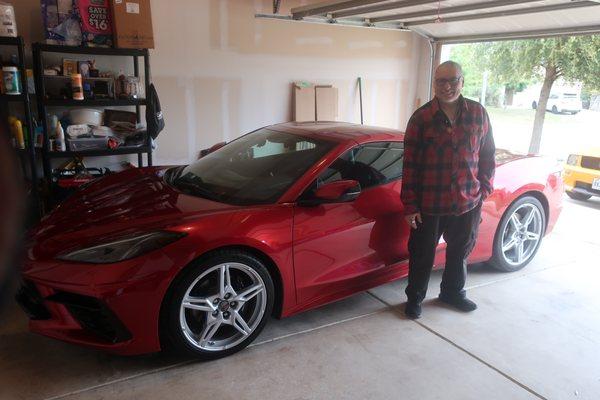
[161,250,275,360]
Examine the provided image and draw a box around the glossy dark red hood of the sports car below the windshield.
[27,167,240,258]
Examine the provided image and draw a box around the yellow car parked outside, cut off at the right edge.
[563,148,600,200]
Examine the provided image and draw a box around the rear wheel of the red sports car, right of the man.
[491,196,546,272]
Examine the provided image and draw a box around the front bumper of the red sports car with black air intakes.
[17,252,180,355]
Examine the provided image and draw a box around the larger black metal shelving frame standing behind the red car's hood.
[33,43,152,206]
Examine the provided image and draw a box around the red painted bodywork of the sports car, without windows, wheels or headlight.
[23,124,562,354]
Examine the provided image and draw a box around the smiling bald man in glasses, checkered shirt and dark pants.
[401,61,496,318]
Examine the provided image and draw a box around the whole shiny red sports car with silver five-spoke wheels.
[18,123,563,359]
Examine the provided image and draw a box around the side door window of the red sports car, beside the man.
[314,142,404,189]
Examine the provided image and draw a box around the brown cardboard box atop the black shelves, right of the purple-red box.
[110,0,154,49]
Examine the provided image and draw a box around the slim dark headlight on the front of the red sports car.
[57,231,186,264]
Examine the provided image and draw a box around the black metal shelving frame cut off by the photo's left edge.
[0,36,41,219]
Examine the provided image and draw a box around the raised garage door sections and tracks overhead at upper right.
[257,0,600,43]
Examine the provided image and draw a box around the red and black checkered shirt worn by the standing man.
[401,96,496,215]
